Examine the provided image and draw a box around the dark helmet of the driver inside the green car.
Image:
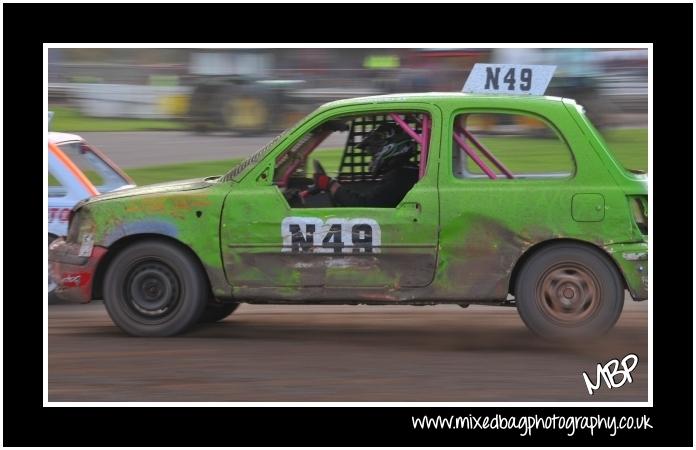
[356,123,417,176]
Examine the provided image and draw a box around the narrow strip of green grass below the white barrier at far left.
[48,106,186,133]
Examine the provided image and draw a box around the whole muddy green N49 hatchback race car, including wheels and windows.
[49,89,648,339]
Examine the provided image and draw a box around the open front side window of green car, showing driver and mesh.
[274,112,432,208]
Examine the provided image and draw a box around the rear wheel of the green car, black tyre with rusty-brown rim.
[515,242,624,340]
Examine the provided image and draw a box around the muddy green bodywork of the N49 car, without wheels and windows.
[51,93,648,334]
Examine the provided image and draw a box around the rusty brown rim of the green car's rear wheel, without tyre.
[536,262,602,325]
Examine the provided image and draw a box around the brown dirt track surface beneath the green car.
[48,301,648,402]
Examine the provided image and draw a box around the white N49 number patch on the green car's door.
[280,217,382,254]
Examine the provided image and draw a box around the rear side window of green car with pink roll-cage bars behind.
[452,113,575,180]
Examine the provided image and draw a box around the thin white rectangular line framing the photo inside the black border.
[43,43,652,408]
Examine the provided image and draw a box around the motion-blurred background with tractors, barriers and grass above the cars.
[48,48,648,184]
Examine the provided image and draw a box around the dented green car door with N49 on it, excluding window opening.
[221,104,441,289]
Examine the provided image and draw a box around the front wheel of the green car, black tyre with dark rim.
[104,240,209,336]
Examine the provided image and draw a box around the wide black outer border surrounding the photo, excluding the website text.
[2,4,693,446]
